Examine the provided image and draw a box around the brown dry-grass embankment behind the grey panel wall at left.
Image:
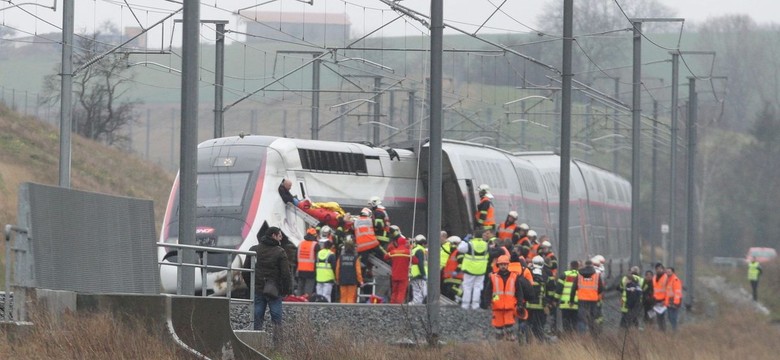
[0,103,173,235]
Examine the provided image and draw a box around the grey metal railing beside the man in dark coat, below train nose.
[157,243,257,321]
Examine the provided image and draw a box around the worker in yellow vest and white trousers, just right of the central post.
[458,232,488,310]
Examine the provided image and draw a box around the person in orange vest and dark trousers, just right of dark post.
[569,260,604,336]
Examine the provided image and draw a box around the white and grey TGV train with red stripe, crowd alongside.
[159,136,631,294]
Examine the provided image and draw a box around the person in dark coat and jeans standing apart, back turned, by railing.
[254,226,293,346]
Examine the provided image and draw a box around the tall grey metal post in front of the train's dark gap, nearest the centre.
[426,0,444,346]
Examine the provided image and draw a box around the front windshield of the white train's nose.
[198,172,251,207]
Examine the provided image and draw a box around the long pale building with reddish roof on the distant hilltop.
[239,11,352,46]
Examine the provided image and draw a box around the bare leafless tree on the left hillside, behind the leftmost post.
[44,25,141,145]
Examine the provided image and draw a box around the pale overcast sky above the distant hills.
[0,0,780,43]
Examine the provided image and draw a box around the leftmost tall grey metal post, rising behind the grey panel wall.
[60,0,75,188]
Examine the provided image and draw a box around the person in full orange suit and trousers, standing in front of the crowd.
[487,255,533,340]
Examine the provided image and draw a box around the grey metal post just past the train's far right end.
[631,21,642,265]
